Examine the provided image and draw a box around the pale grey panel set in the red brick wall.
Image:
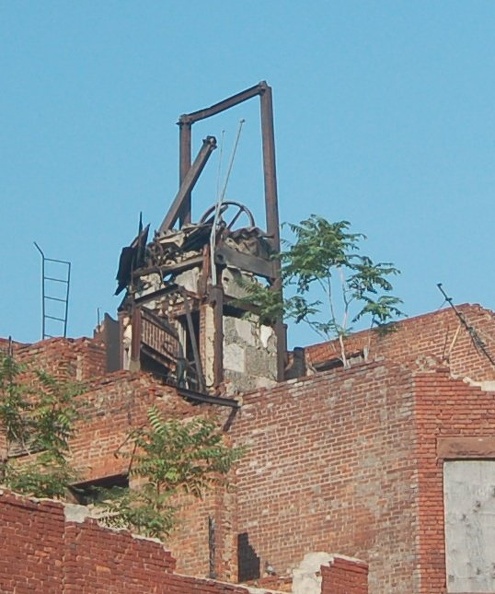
[444,460,495,593]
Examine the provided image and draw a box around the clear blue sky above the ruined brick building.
[0,0,495,344]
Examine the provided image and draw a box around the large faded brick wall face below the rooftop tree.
[232,363,418,594]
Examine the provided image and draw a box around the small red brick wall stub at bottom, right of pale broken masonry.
[321,556,368,594]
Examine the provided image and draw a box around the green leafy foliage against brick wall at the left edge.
[0,353,81,497]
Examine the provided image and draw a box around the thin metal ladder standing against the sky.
[34,242,71,340]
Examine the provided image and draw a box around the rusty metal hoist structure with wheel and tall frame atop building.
[116,82,285,401]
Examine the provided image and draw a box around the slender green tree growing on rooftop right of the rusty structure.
[240,215,403,366]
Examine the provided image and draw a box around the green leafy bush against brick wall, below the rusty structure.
[99,408,242,537]
